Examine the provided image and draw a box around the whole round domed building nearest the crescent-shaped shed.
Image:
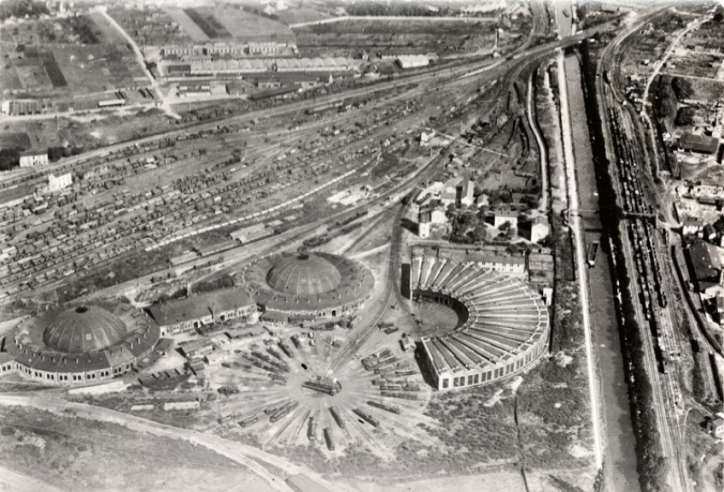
[243,253,375,322]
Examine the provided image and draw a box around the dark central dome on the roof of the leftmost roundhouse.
[39,306,128,354]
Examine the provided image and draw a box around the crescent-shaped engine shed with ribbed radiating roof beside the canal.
[410,248,550,391]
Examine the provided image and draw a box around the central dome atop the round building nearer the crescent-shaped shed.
[266,254,342,296]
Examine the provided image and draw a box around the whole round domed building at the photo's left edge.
[0,303,160,385]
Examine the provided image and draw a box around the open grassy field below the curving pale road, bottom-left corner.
[0,408,269,492]
